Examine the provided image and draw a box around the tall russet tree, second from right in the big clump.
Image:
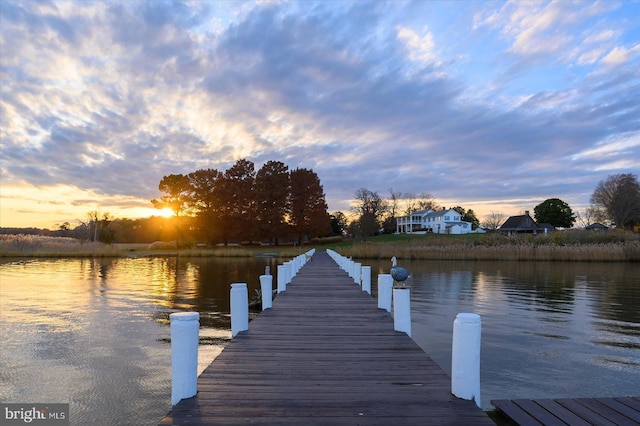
[254,161,291,245]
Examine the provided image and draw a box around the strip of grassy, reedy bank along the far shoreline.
[5,231,640,262]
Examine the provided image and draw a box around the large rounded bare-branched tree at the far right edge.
[591,173,640,228]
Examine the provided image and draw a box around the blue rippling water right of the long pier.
[363,261,640,408]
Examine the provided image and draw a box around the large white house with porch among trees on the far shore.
[396,209,473,234]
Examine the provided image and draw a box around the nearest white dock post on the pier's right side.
[451,313,482,407]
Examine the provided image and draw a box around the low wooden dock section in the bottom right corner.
[491,398,640,426]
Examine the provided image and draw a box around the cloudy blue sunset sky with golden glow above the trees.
[0,0,640,228]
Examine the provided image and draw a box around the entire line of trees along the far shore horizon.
[0,171,640,244]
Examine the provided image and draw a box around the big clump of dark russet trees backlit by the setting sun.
[151,159,331,245]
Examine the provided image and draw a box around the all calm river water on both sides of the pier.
[0,258,640,425]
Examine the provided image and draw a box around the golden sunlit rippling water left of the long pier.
[0,257,276,425]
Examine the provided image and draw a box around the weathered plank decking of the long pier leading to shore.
[161,252,494,426]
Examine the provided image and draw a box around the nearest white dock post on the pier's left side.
[169,312,200,405]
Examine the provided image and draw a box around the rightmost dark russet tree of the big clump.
[289,169,331,243]
